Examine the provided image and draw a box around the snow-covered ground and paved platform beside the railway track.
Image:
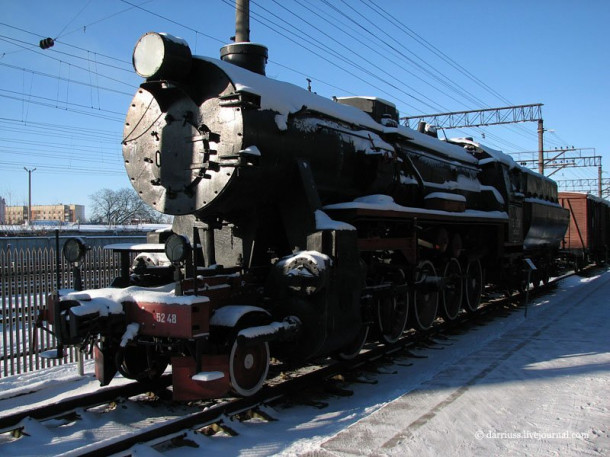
[0,272,610,457]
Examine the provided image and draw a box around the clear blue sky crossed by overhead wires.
[0,0,610,217]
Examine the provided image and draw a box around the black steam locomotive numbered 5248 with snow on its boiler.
[40,28,569,400]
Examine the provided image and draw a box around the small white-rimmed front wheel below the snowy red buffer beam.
[229,340,269,397]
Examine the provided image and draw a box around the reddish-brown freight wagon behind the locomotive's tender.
[559,192,610,267]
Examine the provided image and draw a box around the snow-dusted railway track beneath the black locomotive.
[0,268,580,456]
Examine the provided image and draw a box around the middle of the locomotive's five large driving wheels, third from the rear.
[412,260,439,330]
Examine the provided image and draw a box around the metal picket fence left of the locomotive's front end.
[0,247,120,377]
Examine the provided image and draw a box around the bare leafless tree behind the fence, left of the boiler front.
[90,188,167,227]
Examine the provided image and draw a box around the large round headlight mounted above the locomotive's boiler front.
[133,32,192,80]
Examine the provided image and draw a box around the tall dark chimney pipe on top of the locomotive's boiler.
[220,0,267,75]
